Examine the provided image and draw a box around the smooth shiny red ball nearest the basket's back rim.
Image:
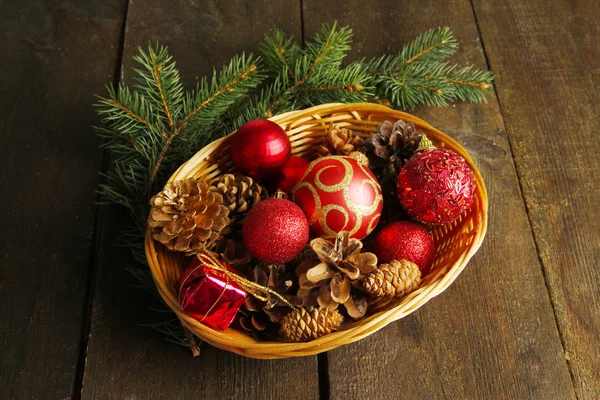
[230,119,292,179]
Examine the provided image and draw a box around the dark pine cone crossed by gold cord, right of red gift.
[239,265,300,341]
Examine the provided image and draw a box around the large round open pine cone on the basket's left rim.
[148,178,229,255]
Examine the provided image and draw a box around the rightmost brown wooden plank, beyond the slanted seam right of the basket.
[474,0,600,399]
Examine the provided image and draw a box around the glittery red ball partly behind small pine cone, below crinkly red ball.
[373,221,435,275]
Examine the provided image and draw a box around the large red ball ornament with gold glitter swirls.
[292,156,383,239]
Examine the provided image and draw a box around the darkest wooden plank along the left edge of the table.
[0,0,125,399]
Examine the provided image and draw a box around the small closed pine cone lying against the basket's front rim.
[281,307,344,342]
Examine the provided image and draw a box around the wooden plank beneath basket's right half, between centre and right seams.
[303,0,573,399]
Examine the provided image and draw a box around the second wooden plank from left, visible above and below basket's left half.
[83,0,319,399]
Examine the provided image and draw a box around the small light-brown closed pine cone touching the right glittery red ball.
[362,260,421,298]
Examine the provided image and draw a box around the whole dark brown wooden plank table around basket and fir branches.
[0,0,600,399]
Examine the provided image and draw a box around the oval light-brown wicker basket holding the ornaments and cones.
[146,103,488,358]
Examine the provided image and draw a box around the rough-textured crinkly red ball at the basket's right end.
[398,149,475,225]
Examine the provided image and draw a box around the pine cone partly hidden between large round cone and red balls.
[210,174,269,223]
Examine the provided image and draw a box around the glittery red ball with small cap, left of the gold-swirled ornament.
[242,198,308,264]
